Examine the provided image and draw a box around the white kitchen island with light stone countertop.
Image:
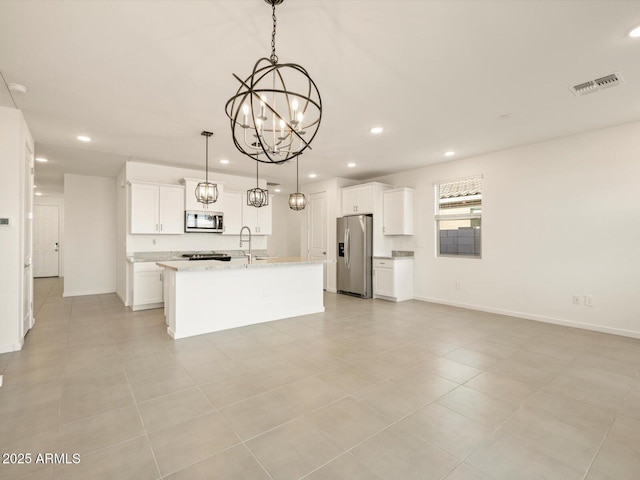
[157,258,325,339]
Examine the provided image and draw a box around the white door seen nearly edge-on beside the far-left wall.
[21,143,33,337]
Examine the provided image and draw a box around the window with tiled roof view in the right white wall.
[435,177,482,258]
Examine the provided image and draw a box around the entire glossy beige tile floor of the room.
[0,279,640,480]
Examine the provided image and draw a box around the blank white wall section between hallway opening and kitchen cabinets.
[63,174,117,297]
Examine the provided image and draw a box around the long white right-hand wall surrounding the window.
[375,122,640,337]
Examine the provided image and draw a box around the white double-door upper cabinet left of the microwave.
[131,183,184,234]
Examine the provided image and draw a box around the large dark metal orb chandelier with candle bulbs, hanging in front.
[225,0,322,163]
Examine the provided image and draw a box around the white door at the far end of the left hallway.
[33,205,60,277]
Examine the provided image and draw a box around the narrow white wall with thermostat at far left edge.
[0,107,33,353]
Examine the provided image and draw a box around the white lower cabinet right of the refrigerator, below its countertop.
[373,257,413,302]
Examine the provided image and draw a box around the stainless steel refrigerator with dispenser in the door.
[337,215,373,298]
